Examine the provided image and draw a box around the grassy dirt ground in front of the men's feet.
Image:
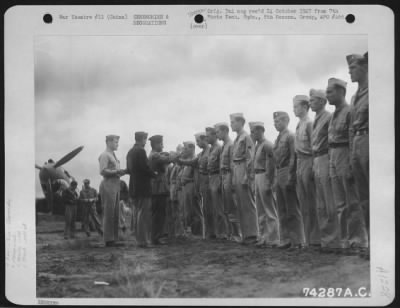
[36,214,370,298]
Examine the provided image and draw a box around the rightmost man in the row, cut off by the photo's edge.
[346,52,369,257]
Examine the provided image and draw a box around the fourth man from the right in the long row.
[293,95,321,247]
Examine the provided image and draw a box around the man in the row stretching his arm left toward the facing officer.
[179,132,209,238]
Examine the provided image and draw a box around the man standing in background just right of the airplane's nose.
[79,179,103,236]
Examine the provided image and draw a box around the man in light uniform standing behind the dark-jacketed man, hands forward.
[99,135,126,247]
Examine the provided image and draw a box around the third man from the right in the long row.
[310,89,340,252]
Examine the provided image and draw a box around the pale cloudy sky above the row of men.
[34,35,368,197]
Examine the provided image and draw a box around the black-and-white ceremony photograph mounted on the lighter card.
[4,4,394,305]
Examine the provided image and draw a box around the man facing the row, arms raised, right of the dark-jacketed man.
[149,135,172,245]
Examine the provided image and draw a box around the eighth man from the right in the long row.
[214,122,241,241]
